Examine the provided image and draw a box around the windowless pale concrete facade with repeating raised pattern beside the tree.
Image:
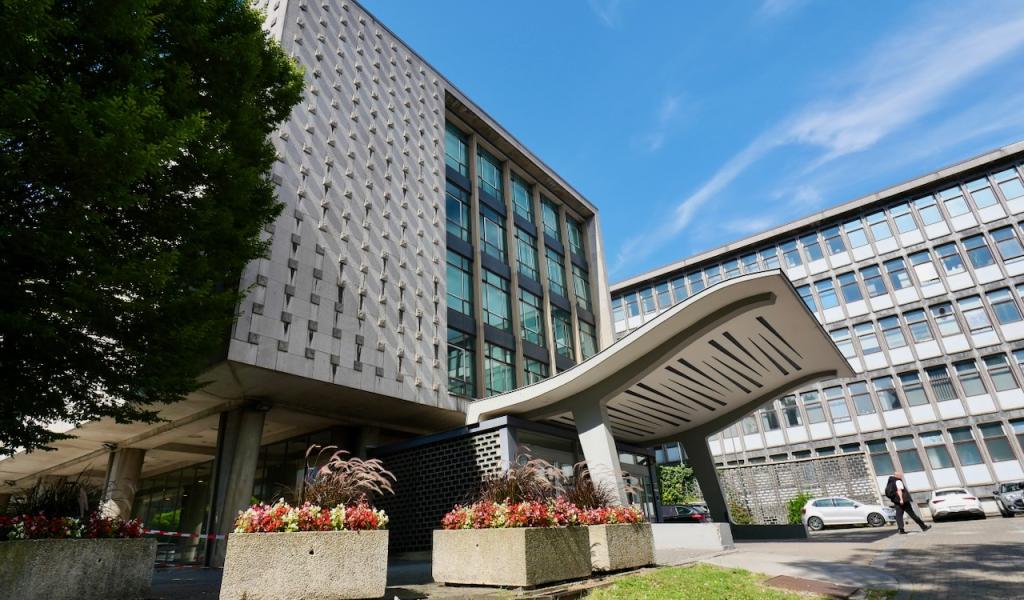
[235,0,458,409]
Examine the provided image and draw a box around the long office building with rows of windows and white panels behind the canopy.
[612,142,1024,496]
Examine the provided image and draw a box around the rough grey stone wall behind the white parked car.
[719,453,881,524]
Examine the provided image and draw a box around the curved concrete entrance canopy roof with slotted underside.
[467,270,853,445]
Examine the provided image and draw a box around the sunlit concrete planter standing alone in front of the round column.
[220,530,388,600]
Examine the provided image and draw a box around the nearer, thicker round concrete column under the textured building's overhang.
[207,405,268,566]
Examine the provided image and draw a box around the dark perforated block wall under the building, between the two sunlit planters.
[378,430,505,552]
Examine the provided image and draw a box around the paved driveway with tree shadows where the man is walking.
[703,509,1024,600]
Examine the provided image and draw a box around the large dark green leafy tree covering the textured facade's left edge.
[0,0,302,454]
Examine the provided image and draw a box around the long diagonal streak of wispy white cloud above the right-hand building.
[609,5,1024,273]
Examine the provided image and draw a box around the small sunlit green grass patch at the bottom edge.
[587,564,819,600]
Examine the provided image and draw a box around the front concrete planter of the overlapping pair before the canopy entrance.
[433,527,591,588]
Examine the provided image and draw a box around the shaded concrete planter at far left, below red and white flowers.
[0,538,157,600]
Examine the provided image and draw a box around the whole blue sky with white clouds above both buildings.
[364,0,1024,282]
